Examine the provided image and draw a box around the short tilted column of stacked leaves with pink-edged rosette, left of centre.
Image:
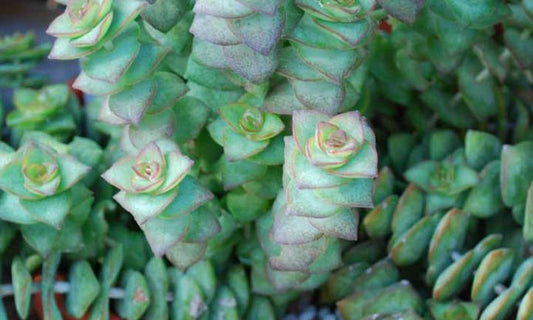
[102,139,220,269]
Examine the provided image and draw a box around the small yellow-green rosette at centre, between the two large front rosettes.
[208,103,285,164]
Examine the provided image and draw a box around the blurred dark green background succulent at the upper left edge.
[0,32,51,87]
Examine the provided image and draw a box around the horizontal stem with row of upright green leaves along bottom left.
[0,245,275,319]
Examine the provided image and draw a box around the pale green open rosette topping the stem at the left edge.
[0,140,91,228]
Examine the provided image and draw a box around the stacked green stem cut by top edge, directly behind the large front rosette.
[265,0,376,115]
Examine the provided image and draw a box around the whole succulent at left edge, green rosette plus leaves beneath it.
[0,135,101,256]
